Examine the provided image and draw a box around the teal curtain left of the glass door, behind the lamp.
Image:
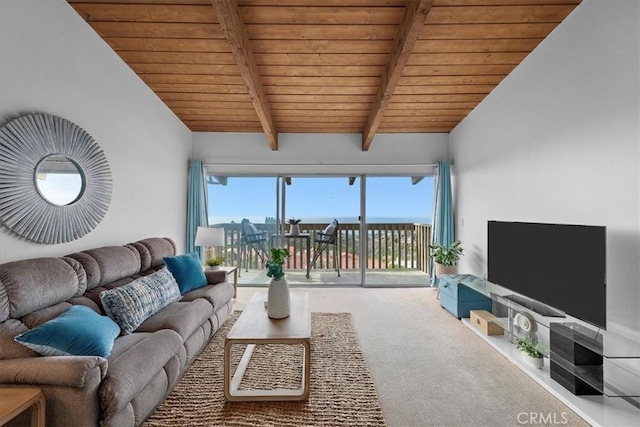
[187,160,209,259]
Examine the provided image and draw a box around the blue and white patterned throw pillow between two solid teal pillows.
[100,268,182,335]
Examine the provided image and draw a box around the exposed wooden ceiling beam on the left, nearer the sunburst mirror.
[211,0,278,151]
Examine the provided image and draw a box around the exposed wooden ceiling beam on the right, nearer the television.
[362,0,433,151]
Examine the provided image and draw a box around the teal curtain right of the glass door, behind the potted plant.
[430,162,455,287]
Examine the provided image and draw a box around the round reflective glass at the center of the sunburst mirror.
[35,154,84,206]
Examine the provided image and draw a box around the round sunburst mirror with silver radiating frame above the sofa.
[0,114,112,244]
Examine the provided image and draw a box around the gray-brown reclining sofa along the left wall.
[0,238,234,427]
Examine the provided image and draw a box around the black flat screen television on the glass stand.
[487,221,607,329]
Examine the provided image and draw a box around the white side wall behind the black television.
[450,0,640,337]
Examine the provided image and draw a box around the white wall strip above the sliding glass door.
[192,132,448,175]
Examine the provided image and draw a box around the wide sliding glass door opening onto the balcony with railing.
[209,175,433,286]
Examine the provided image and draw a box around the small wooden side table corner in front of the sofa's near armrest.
[0,388,46,427]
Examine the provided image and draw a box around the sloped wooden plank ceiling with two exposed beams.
[69,0,581,150]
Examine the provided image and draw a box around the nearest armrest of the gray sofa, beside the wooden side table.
[0,356,107,388]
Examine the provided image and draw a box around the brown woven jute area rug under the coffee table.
[143,311,386,427]
